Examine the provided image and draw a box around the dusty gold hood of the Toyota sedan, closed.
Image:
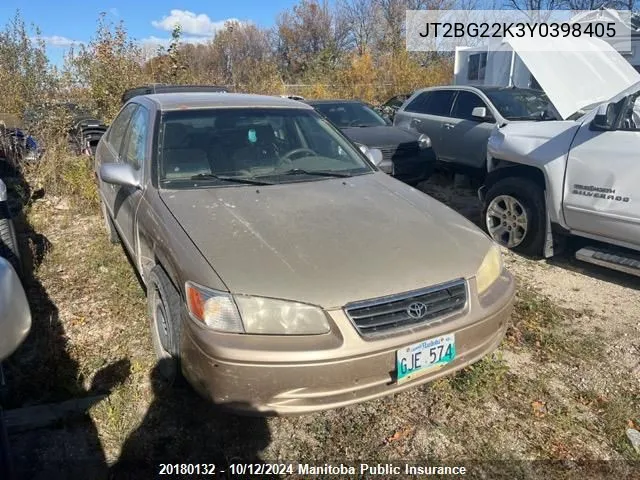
[160,172,491,309]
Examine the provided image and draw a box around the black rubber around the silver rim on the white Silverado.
[482,177,546,257]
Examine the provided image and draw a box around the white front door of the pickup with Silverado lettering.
[563,95,640,249]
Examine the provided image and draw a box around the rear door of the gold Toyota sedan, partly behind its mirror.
[96,103,138,218]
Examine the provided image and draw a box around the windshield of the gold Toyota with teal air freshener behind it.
[158,108,373,188]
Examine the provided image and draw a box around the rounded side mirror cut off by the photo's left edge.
[0,257,31,360]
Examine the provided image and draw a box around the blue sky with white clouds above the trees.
[0,0,296,65]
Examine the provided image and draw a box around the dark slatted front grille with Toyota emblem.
[344,279,467,337]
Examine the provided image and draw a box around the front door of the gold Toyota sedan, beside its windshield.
[113,105,151,252]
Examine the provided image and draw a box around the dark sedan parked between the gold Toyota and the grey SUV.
[306,100,435,185]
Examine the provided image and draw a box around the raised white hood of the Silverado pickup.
[498,36,640,119]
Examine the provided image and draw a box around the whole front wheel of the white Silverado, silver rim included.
[482,177,545,257]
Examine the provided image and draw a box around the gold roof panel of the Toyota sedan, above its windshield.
[143,92,311,111]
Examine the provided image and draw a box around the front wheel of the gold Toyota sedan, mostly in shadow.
[147,265,182,382]
